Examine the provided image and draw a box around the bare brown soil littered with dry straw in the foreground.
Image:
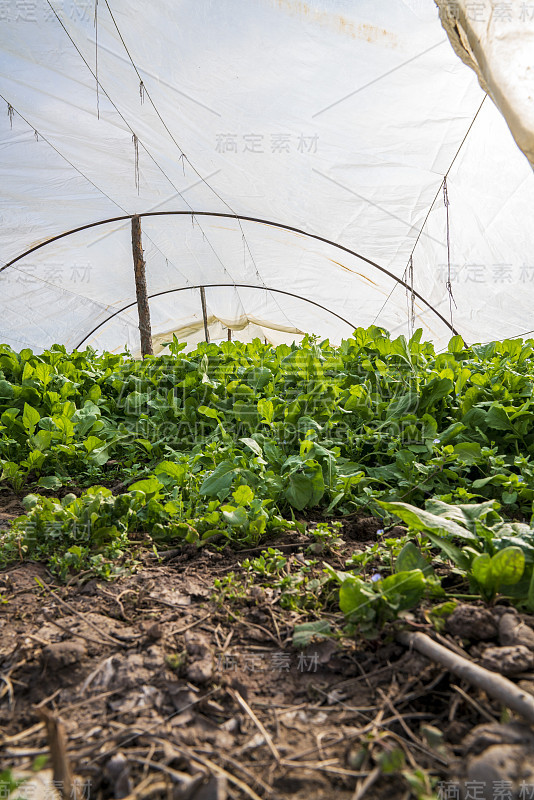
[0,497,532,800]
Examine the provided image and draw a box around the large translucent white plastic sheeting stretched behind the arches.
[0,0,534,354]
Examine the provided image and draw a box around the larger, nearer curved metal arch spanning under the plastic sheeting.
[0,211,458,335]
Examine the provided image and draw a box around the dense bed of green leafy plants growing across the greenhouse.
[0,326,534,592]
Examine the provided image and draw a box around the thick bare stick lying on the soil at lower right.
[397,631,534,724]
